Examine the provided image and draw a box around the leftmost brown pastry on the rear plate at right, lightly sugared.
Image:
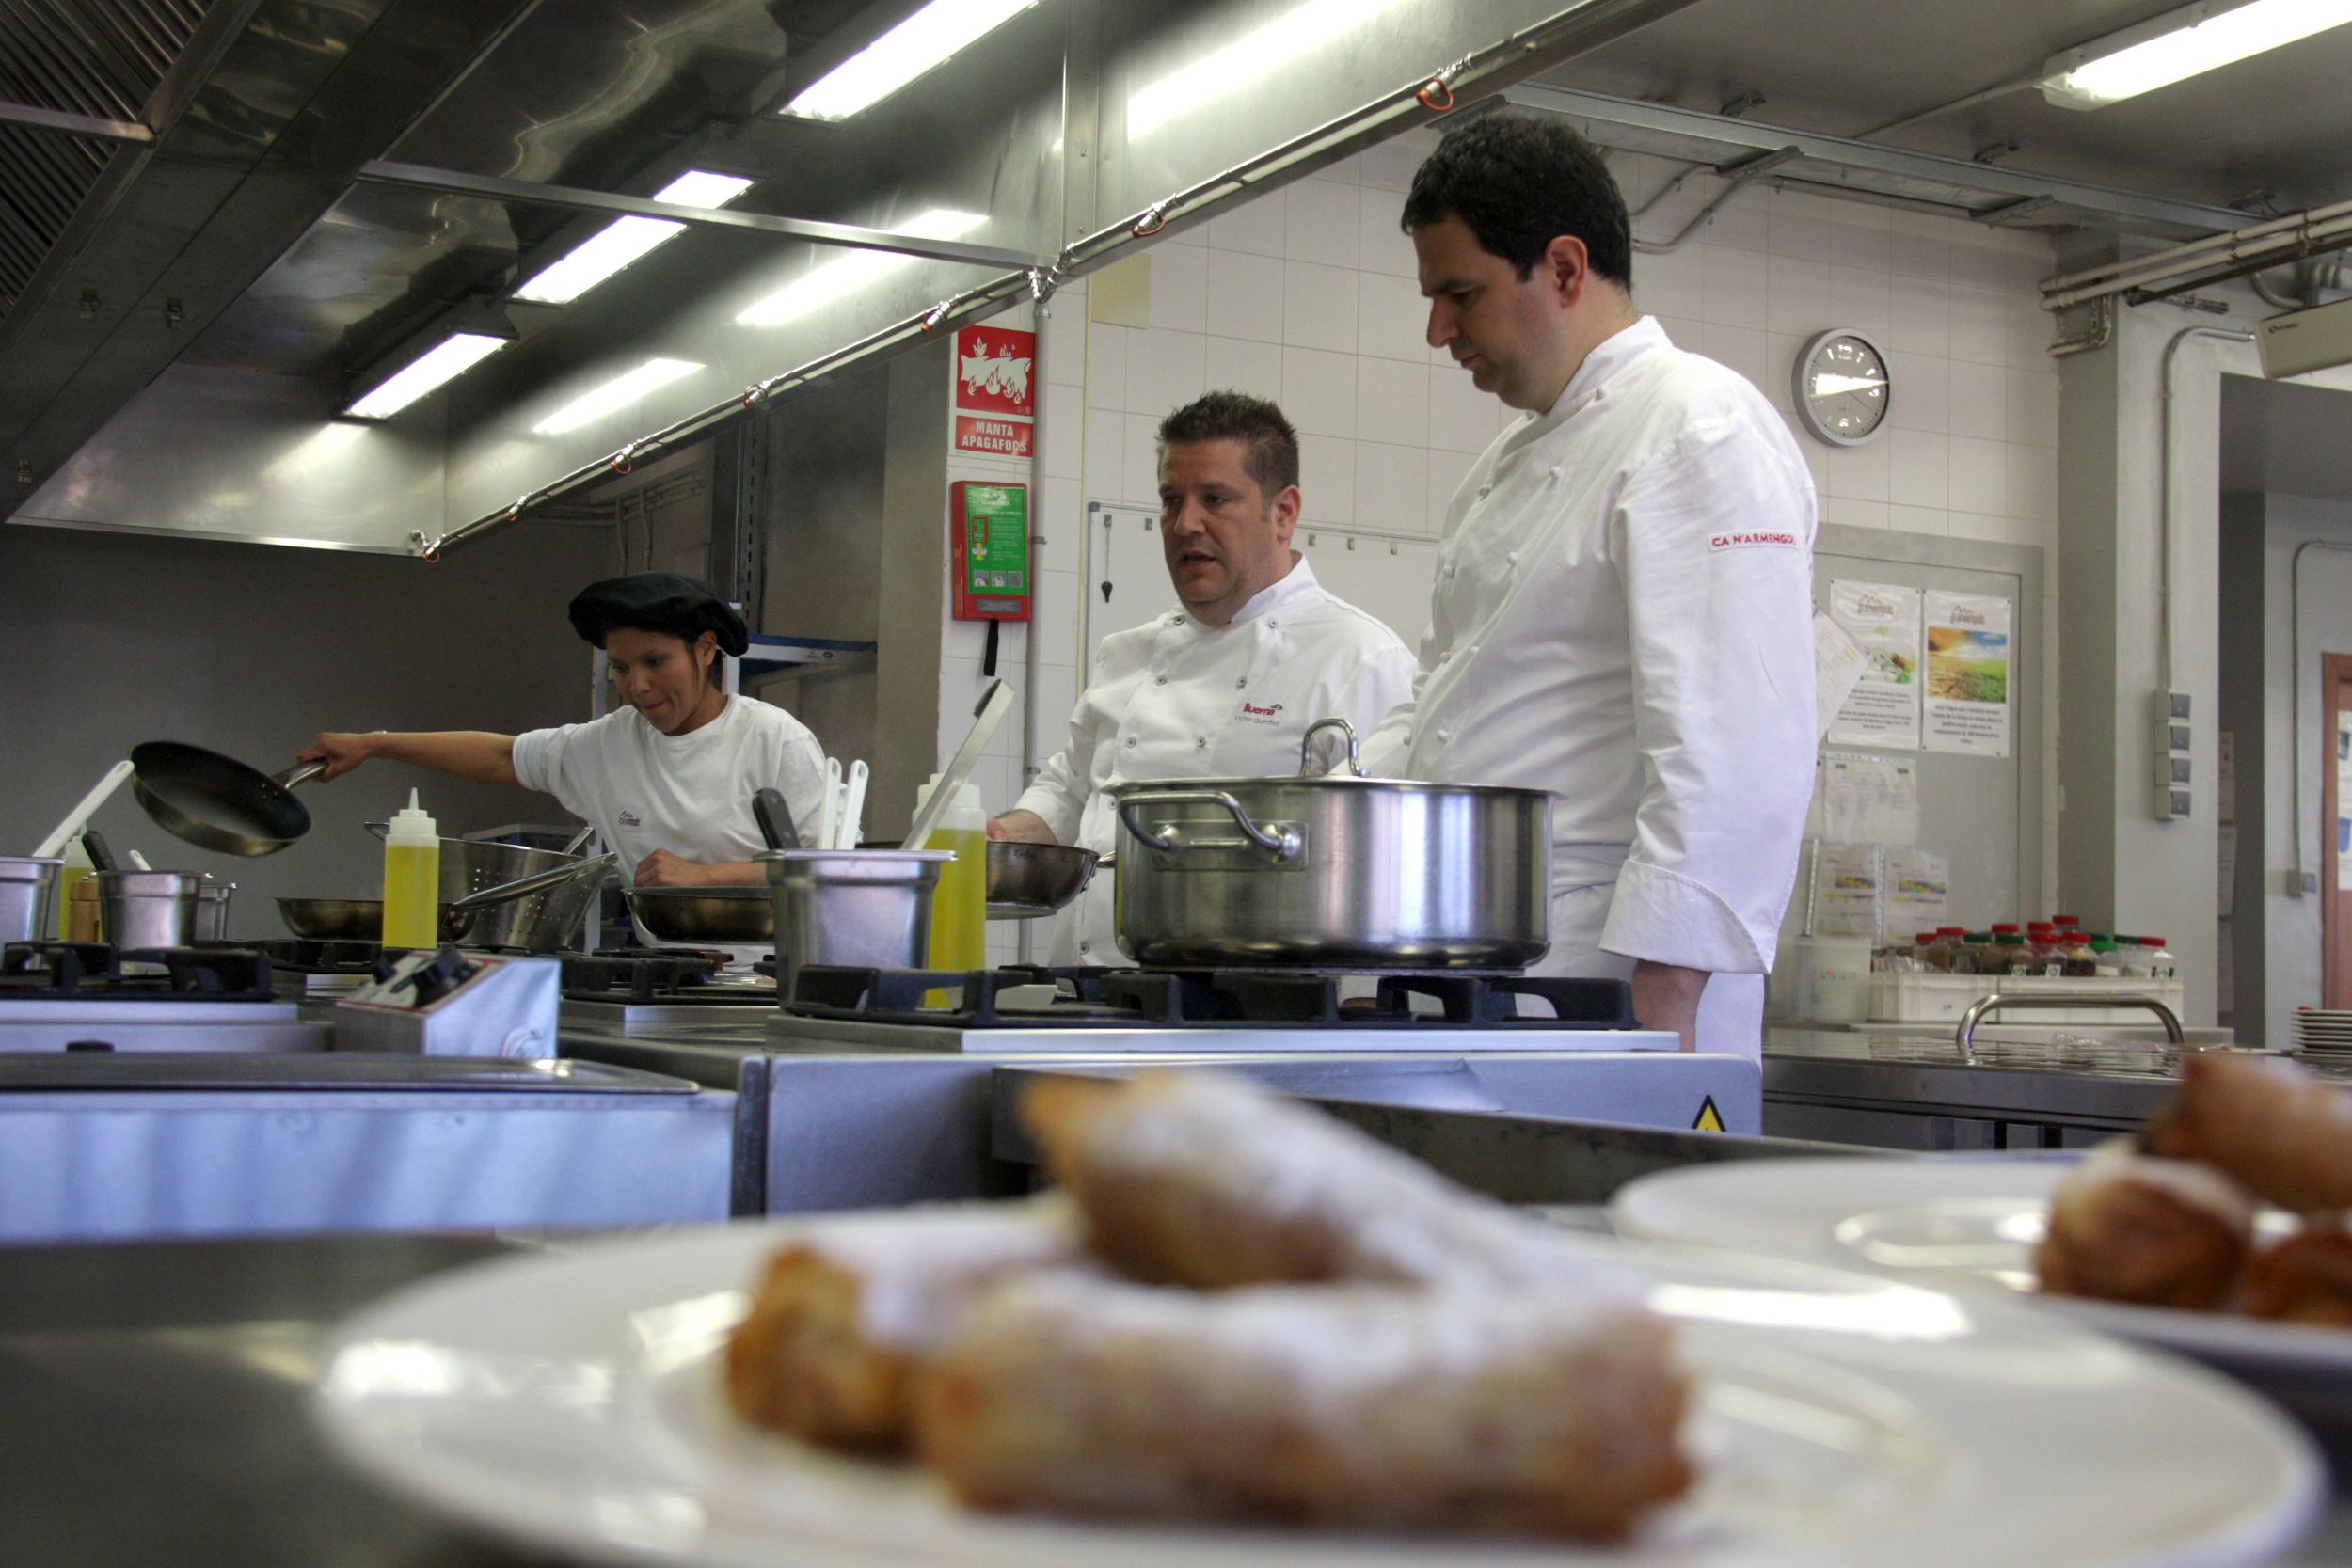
[2035,1143,2253,1312]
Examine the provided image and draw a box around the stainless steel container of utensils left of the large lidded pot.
[760,848,955,997]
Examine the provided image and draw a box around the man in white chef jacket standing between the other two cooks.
[988,392,1414,964]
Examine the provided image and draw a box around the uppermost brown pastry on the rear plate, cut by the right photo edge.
[2145,1051,2352,1213]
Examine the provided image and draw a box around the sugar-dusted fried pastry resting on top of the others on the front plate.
[1021,1074,1628,1291]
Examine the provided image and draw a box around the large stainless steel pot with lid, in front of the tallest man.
[1110,720,1552,969]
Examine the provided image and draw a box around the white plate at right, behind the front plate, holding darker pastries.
[1609,1154,2352,1434]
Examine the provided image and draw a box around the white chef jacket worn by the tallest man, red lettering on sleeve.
[1364,317,1816,1055]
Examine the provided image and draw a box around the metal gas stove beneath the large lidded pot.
[563,966,1762,1213]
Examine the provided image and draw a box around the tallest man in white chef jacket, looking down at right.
[1367,113,1819,1055]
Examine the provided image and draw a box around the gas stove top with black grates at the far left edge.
[0,942,329,1055]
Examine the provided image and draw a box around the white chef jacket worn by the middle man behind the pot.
[1019,557,1414,964]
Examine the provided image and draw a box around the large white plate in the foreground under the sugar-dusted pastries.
[315,1225,2322,1568]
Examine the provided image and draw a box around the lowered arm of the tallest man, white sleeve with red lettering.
[1599,422,1816,1041]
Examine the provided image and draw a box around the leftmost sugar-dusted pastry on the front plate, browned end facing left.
[727,1199,1080,1449]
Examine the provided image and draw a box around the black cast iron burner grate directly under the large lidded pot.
[786,964,1640,1030]
